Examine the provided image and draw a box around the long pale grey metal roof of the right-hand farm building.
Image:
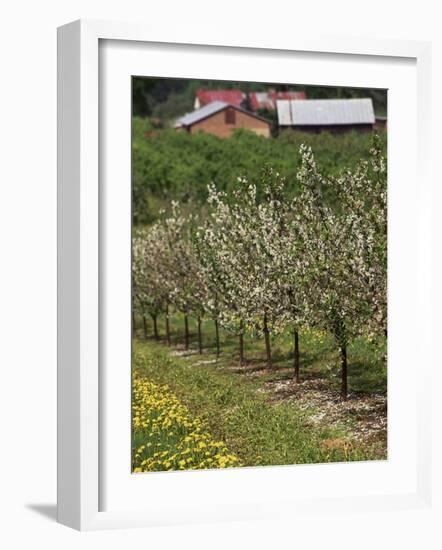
[276,98,375,133]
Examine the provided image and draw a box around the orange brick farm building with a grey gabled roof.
[175,101,270,137]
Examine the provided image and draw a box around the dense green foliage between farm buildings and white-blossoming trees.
[133,121,387,224]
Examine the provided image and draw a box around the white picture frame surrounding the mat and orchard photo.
[58,21,431,530]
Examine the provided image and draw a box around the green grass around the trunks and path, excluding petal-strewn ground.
[134,317,386,466]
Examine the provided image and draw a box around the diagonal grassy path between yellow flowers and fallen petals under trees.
[133,340,384,469]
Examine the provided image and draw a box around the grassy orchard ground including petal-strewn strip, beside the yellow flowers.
[133,316,387,470]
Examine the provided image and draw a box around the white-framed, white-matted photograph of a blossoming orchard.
[58,21,431,530]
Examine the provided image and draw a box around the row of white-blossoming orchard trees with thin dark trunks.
[133,138,387,399]
